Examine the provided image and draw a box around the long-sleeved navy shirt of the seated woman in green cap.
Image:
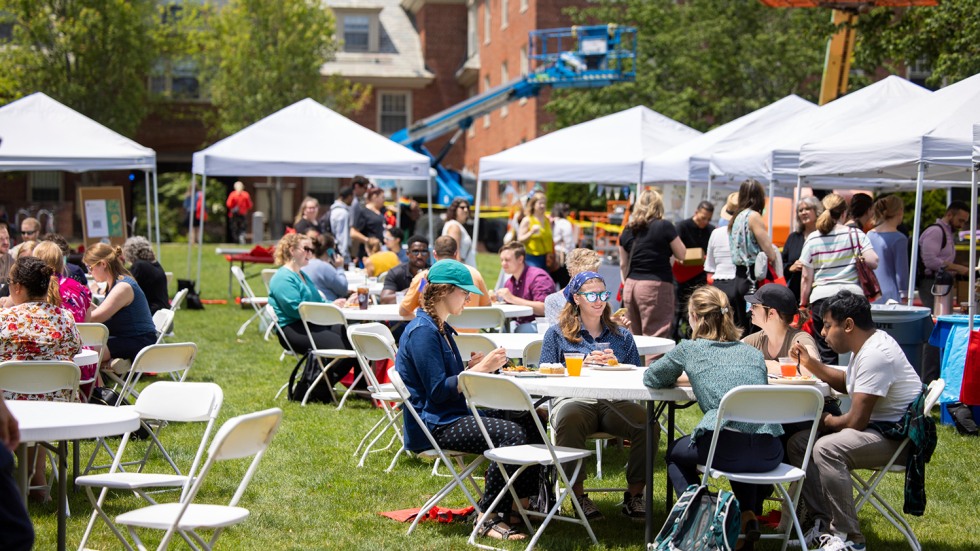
[395,308,471,451]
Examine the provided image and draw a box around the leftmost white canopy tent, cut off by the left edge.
[0,92,160,248]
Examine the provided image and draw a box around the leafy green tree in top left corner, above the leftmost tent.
[0,0,156,136]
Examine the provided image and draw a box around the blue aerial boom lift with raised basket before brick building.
[391,24,636,205]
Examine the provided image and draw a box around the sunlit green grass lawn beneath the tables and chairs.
[24,245,980,551]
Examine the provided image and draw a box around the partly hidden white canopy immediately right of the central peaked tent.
[643,94,817,228]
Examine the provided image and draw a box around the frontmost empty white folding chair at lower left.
[116,408,282,550]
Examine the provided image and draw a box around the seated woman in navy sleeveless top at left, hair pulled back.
[83,243,157,360]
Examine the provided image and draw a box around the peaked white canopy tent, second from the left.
[188,98,432,292]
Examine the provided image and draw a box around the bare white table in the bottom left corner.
[7,400,140,551]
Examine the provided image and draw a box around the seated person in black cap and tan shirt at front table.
[742,283,817,366]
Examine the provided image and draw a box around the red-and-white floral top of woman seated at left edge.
[0,302,82,402]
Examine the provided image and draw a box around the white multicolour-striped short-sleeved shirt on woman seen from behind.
[800,224,873,303]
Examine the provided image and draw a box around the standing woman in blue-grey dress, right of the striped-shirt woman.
[868,195,909,304]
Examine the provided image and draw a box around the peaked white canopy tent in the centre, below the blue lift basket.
[473,105,701,246]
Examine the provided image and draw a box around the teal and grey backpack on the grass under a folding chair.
[653,484,742,551]
